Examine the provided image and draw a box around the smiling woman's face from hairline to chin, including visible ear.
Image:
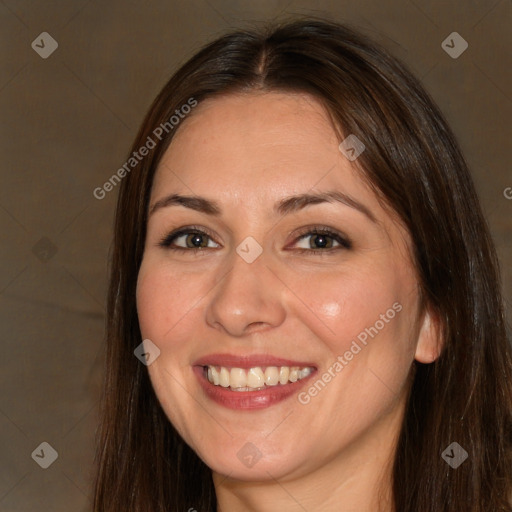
[137,93,436,481]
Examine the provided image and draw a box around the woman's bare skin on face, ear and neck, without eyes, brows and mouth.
[137,92,439,512]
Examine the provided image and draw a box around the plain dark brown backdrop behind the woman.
[0,0,512,512]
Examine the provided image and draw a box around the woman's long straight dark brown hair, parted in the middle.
[94,20,512,512]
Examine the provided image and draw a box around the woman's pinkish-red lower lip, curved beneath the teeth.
[194,366,315,410]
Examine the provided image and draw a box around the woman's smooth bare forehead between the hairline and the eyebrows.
[153,92,375,207]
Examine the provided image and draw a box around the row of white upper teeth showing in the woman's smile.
[206,366,313,391]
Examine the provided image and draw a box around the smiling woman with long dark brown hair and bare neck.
[95,21,512,512]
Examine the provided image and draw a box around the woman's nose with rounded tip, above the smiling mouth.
[206,253,286,337]
